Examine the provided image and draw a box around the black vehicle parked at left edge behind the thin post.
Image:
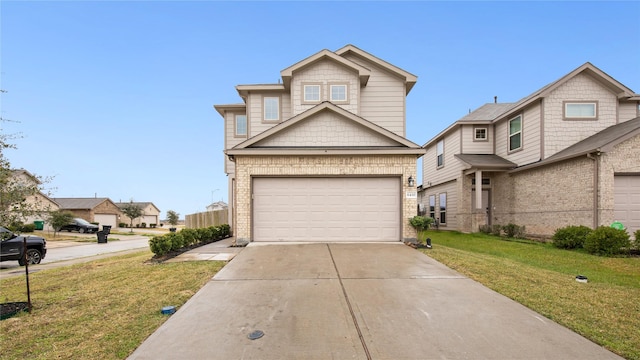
[0,226,47,266]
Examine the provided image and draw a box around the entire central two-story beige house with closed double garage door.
[215,45,424,242]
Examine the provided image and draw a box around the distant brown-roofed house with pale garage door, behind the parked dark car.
[53,198,122,228]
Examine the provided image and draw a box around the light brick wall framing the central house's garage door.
[234,155,417,241]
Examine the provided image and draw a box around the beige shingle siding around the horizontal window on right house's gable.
[544,74,618,158]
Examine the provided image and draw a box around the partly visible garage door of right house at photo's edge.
[614,175,640,236]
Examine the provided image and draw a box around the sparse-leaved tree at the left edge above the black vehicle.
[0,119,50,226]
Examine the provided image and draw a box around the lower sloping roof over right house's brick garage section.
[512,117,640,172]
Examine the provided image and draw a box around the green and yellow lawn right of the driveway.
[422,231,640,360]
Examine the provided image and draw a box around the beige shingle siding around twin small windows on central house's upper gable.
[291,60,360,116]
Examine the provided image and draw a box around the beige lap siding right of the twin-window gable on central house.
[346,54,406,136]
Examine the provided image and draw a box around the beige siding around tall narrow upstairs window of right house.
[494,104,541,166]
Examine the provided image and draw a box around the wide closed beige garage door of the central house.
[252,177,401,241]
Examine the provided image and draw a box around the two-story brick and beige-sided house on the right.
[420,63,640,237]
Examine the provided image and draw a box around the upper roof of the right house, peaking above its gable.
[423,62,640,147]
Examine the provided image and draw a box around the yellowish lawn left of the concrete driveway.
[0,251,225,359]
